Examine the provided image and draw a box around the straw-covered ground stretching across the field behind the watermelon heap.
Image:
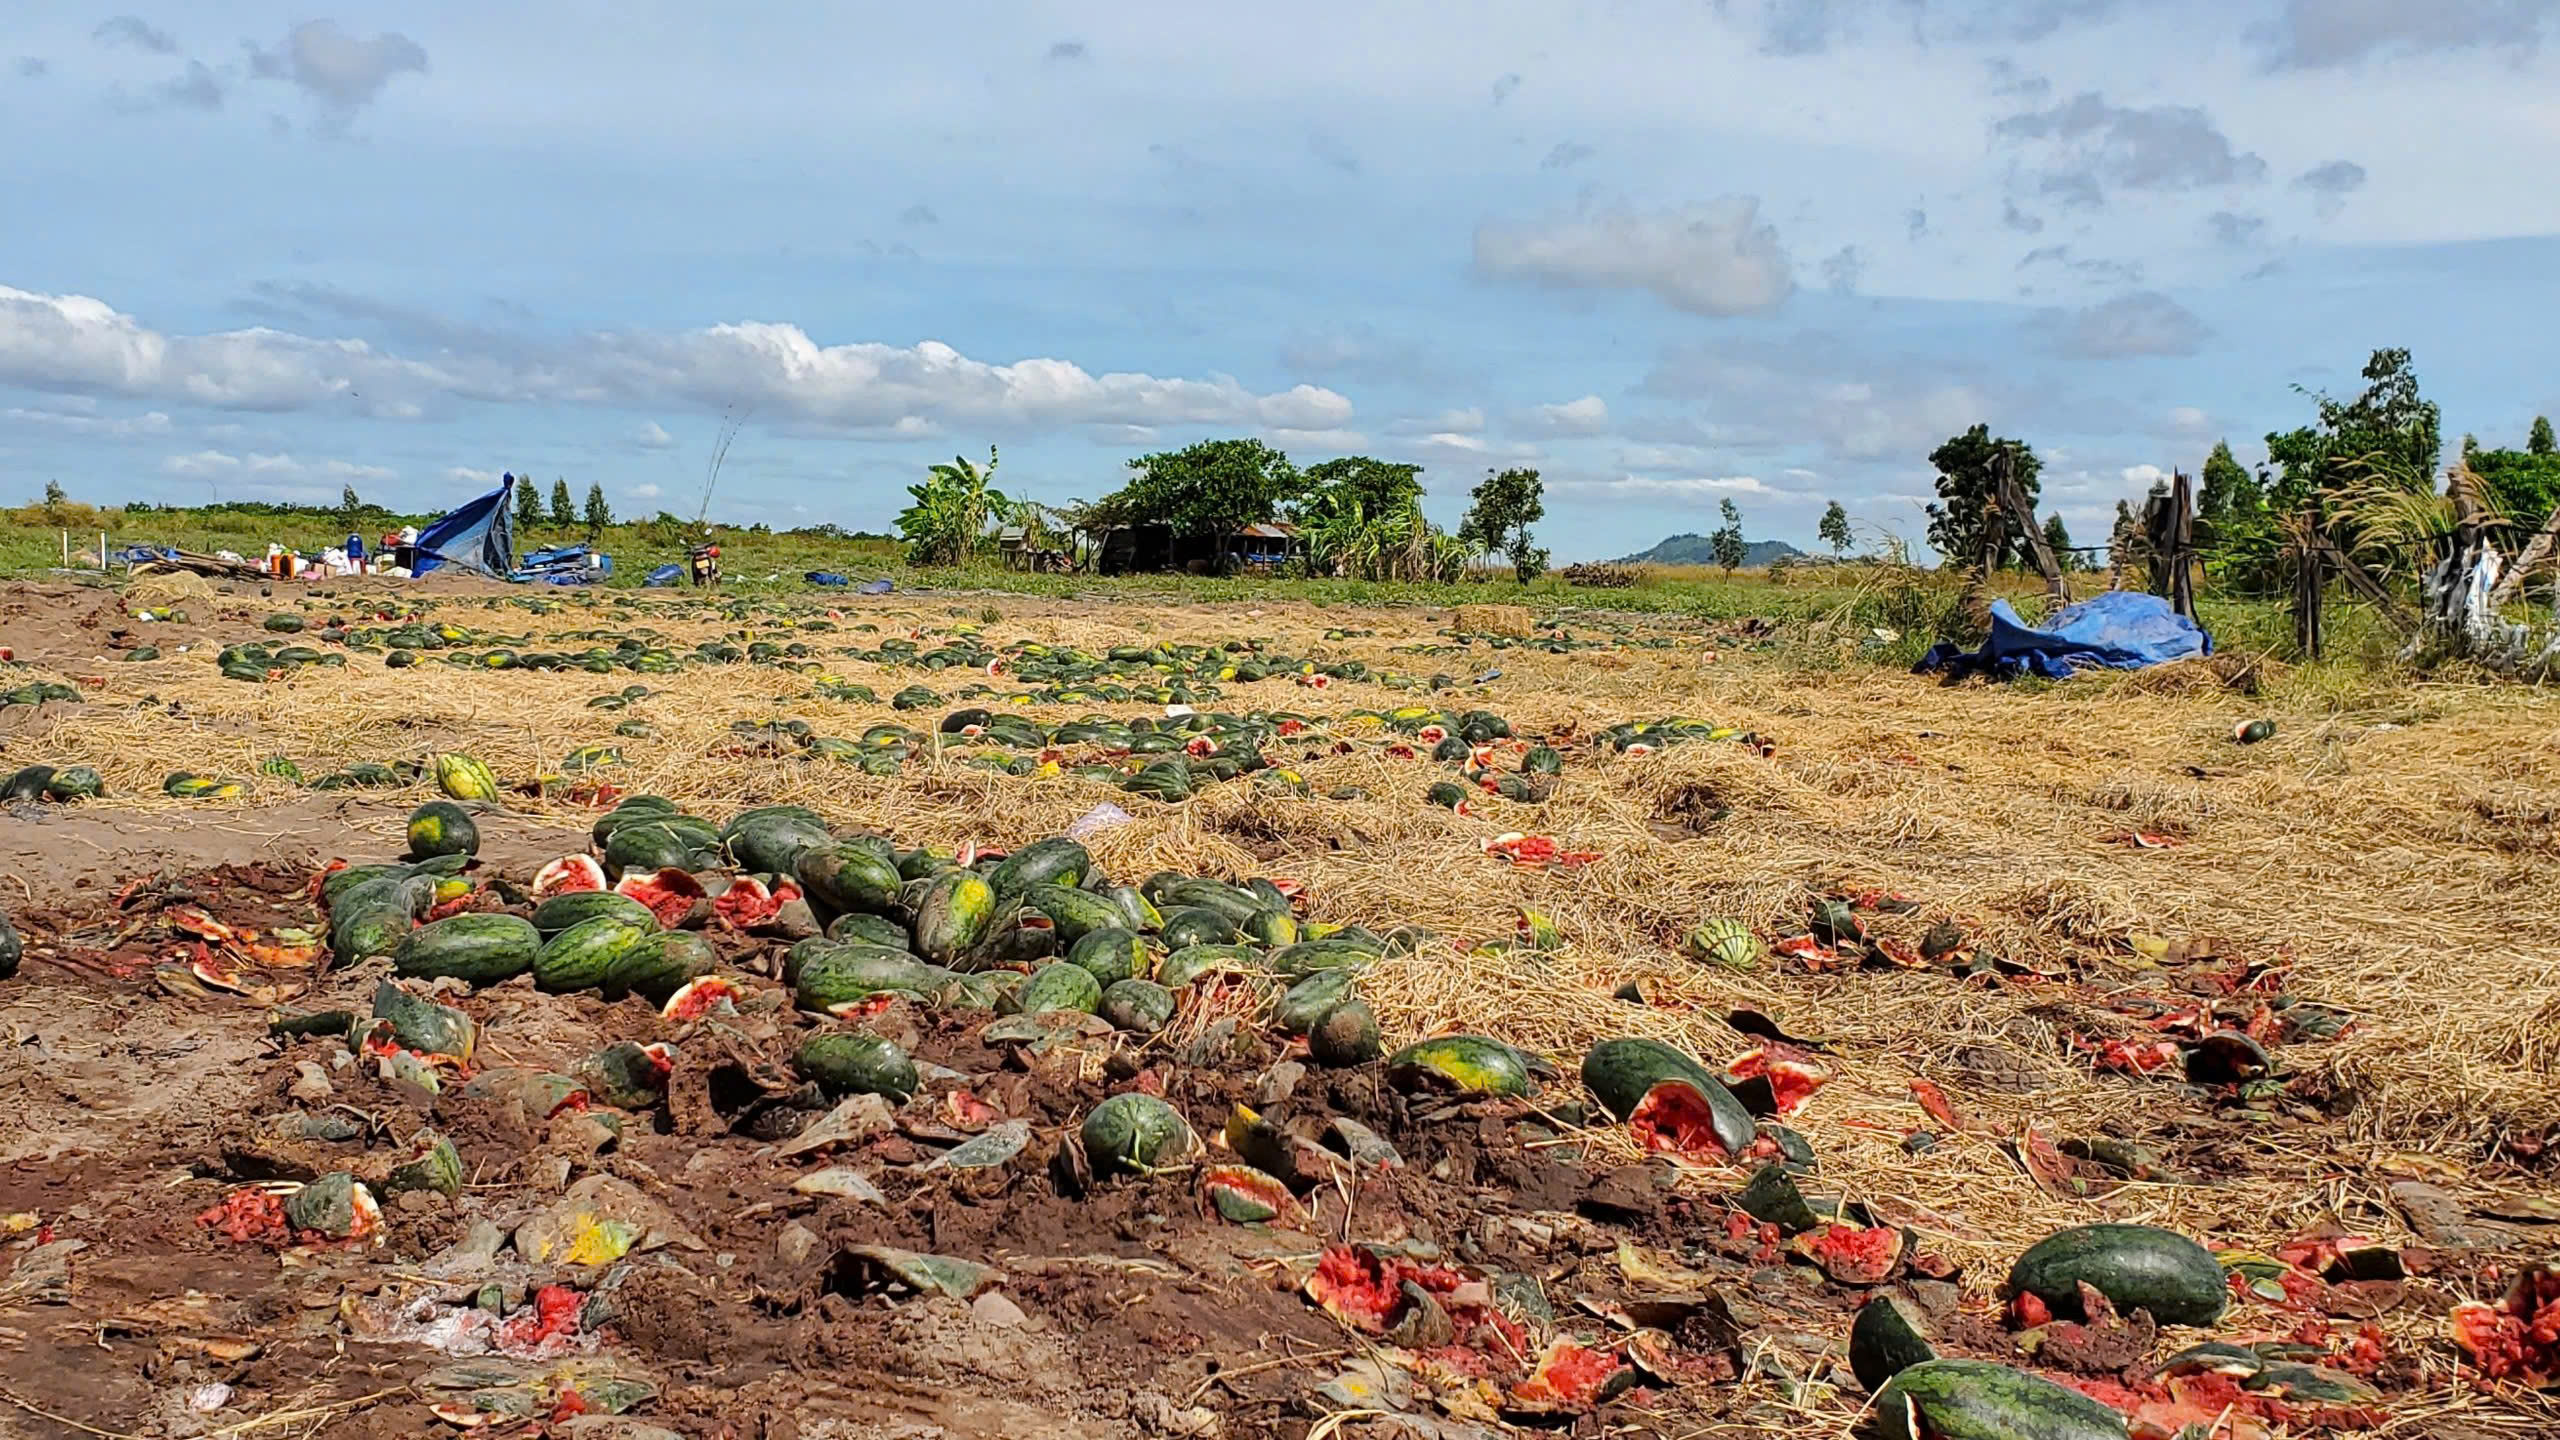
[0,573,2560,1435]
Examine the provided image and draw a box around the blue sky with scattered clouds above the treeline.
[0,0,2560,559]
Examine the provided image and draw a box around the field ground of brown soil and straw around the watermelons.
[0,573,2560,1440]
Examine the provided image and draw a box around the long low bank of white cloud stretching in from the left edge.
[0,287,1352,433]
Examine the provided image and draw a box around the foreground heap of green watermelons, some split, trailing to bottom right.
[264,778,2373,1440]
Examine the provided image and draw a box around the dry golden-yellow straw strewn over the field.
[5,576,2560,1420]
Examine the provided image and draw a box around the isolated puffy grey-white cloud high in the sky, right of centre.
[1475,195,1795,315]
